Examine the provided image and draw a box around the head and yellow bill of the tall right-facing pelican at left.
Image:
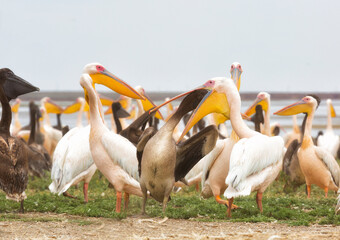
[83,63,144,99]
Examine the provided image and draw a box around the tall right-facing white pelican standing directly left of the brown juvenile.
[80,63,143,212]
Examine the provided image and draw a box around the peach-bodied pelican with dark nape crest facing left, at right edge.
[274,95,340,198]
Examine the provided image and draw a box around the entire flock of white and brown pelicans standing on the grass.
[0,63,340,217]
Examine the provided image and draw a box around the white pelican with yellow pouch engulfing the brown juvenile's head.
[182,77,285,217]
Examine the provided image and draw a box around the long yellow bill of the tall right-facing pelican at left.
[90,70,144,99]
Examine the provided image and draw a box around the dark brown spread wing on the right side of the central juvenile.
[175,125,218,181]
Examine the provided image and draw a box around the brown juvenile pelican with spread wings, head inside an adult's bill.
[137,90,218,213]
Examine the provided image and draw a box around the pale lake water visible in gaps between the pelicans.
[9,99,340,139]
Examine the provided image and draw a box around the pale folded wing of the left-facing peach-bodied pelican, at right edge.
[314,146,340,187]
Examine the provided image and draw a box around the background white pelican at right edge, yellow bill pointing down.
[317,99,340,158]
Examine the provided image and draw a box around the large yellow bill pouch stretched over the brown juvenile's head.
[177,89,230,142]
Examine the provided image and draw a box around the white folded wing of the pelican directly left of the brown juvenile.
[101,131,139,181]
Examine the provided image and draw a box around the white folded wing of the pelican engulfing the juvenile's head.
[226,135,285,190]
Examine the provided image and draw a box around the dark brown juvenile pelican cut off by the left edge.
[0,68,39,212]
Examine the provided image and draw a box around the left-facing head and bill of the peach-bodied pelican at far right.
[274,95,320,116]
